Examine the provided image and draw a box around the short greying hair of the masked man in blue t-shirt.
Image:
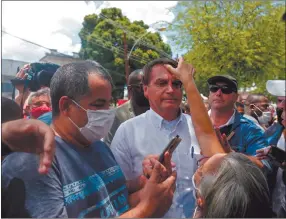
[50,60,112,117]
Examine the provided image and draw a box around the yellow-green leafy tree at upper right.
[169,0,285,94]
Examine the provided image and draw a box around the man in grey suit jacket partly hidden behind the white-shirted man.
[104,69,150,146]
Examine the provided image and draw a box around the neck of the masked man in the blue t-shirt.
[51,118,90,147]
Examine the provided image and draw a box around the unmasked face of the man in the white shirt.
[144,65,183,115]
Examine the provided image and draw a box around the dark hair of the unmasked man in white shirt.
[143,58,178,85]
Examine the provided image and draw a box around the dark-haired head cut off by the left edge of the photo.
[1,97,23,124]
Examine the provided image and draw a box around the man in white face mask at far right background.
[244,94,273,130]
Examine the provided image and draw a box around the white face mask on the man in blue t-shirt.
[68,100,115,143]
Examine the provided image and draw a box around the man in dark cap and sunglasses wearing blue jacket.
[207,75,271,171]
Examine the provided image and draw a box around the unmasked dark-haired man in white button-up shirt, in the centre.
[111,58,200,218]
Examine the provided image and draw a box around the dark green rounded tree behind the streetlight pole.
[79,8,172,98]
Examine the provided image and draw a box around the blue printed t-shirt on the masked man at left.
[2,137,129,218]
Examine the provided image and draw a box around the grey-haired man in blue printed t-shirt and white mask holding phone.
[2,61,176,218]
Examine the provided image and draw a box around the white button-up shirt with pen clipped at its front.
[111,109,201,218]
